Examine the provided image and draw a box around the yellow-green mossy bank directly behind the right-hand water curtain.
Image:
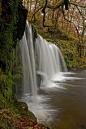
[36,23,86,69]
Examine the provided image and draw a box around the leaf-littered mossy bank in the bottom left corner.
[0,94,50,129]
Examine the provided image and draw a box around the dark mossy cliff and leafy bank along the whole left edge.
[0,0,48,129]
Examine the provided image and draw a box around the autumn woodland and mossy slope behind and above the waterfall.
[23,0,86,69]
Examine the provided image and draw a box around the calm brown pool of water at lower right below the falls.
[39,70,86,129]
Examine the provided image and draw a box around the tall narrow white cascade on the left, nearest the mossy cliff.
[20,21,37,101]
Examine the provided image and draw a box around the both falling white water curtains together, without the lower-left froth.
[17,21,67,97]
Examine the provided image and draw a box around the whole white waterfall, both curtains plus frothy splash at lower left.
[16,21,67,121]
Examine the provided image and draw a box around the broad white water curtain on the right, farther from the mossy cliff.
[35,35,67,85]
